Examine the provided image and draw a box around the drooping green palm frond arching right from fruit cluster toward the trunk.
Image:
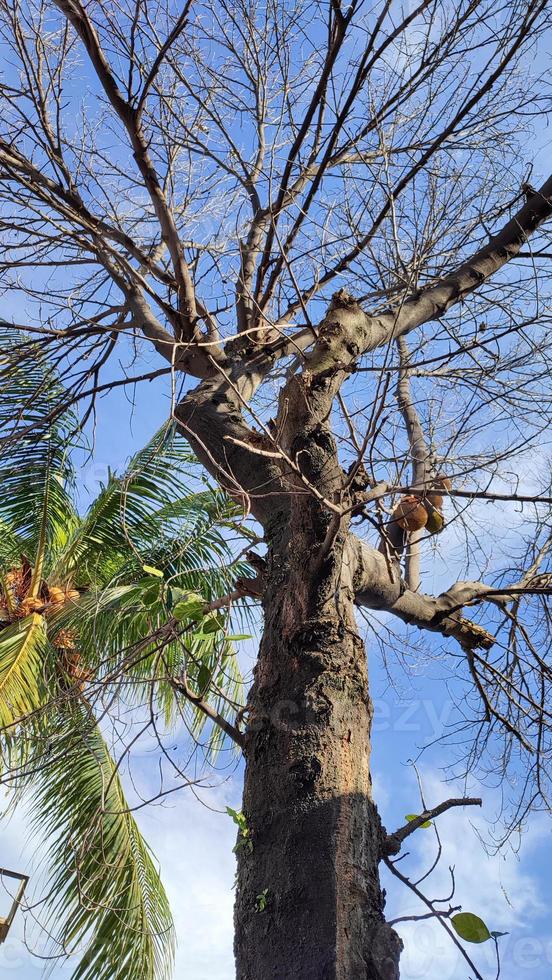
[56,576,244,747]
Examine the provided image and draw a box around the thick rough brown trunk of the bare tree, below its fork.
[236,508,401,980]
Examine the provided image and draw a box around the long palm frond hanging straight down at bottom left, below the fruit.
[33,702,174,980]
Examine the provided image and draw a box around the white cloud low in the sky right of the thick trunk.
[386,772,552,980]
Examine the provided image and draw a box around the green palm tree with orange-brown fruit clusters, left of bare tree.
[0,334,248,980]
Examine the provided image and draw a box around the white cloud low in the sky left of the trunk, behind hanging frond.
[0,780,241,980]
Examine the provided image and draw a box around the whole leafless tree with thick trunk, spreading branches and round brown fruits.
[0,0,552,980]
